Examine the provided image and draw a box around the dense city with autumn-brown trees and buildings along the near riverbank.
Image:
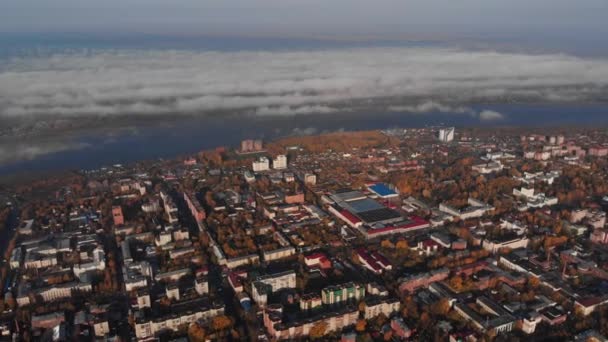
[0,127,608,342]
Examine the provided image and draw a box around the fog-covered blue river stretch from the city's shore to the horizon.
[0,34,608,175]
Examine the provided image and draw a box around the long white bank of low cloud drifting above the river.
[0,48,608,120]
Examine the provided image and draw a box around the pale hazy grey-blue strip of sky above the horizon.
[0,0,608,37]
